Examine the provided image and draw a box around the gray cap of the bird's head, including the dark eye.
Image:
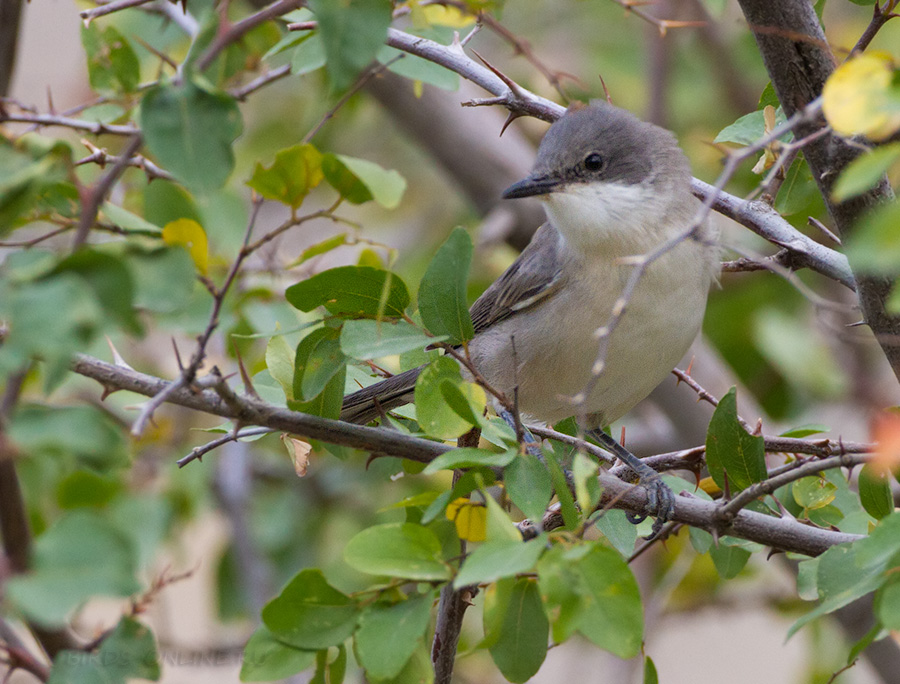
[531,100,688,185]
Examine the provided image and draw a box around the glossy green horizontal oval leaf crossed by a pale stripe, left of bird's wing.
[285,266,409,317]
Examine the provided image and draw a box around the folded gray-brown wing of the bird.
[469,223,562,334]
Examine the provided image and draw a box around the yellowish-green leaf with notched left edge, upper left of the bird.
[247,143,323,209]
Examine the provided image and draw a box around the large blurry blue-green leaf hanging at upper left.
[141,81,242,192]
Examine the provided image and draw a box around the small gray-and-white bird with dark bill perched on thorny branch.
[341,100,720,536]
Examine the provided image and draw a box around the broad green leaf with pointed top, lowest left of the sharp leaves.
[262,568,359,649]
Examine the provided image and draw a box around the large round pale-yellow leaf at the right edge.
[822,52,900,140]
